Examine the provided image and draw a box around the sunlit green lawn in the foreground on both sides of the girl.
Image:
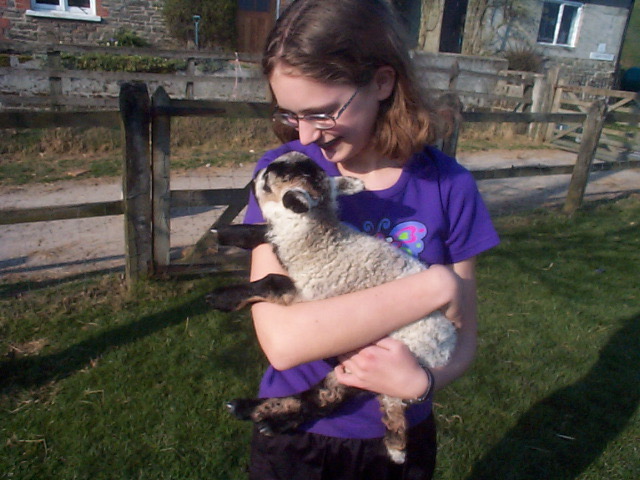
[0,196,640,480]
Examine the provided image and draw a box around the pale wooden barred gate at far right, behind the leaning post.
[546,84,640,162]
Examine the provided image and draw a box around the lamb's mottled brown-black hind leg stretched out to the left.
[227,372,363,435]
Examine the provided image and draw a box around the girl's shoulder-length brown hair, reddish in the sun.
[262,0,437,161]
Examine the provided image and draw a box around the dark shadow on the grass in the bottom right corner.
[467,314,640,480]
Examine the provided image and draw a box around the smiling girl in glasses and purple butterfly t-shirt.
[245,0,498,480]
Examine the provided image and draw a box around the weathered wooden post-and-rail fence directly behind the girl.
[0,82,640,282]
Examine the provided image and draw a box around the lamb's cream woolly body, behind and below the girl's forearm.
[265,204,456,367]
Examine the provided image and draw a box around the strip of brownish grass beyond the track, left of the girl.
[0,118,277,186]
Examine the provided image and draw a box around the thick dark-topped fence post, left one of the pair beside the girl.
[119,82,152,287]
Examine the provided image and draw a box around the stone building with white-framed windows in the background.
[0,0,634,86]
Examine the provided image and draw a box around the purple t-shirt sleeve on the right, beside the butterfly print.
[443,166,500,263]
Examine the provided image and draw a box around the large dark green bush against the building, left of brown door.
[162,0,237,49]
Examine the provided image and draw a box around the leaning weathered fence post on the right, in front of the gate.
[563,100,607,215]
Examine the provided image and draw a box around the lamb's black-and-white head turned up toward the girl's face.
[254,152,364,220]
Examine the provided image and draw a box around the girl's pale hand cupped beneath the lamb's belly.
[335,337,429,399]
